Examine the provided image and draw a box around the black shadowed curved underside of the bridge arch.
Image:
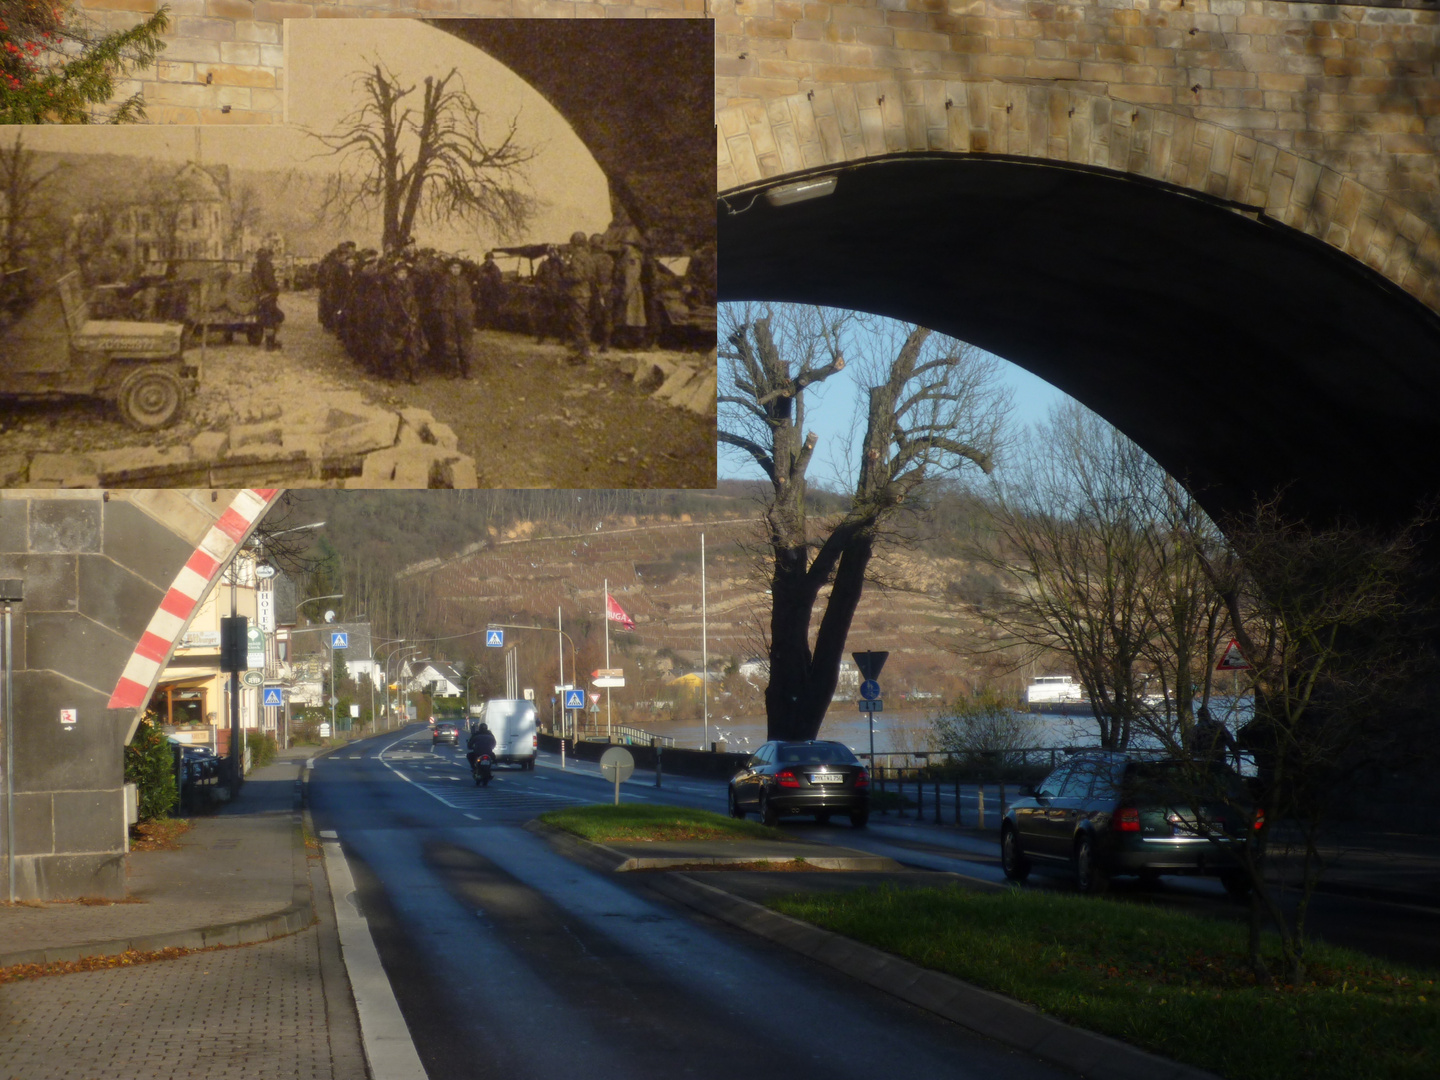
[719,154,1440,532]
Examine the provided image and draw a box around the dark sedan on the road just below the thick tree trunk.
[730,740,870,829]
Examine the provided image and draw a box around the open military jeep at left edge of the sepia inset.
[0,272,200,431]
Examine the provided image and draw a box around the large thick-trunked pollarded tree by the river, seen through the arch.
[720,305,1008,739]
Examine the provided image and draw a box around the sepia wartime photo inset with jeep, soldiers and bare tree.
[0,19,716,488]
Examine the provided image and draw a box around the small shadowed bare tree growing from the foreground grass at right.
[1202,498,1426,982]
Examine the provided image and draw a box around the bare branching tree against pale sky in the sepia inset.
[310,60,536,251]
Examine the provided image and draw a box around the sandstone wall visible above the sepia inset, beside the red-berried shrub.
[76,0,707,124]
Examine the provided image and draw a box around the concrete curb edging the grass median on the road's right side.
[535,821,1221,1080]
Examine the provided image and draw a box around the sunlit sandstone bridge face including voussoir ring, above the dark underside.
[716,0,1440,312]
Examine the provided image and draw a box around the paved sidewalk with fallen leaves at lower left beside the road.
[0,750,367,1080]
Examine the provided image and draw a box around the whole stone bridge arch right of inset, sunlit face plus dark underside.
[716,0,1440,529]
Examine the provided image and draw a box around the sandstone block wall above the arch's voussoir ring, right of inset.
[714,0,1440,234]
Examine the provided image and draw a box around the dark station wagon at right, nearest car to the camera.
[999,750,1254,896]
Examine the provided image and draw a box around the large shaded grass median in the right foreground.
[769,887,1440,1080]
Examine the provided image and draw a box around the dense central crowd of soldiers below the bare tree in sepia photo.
[315,240,501,383]
